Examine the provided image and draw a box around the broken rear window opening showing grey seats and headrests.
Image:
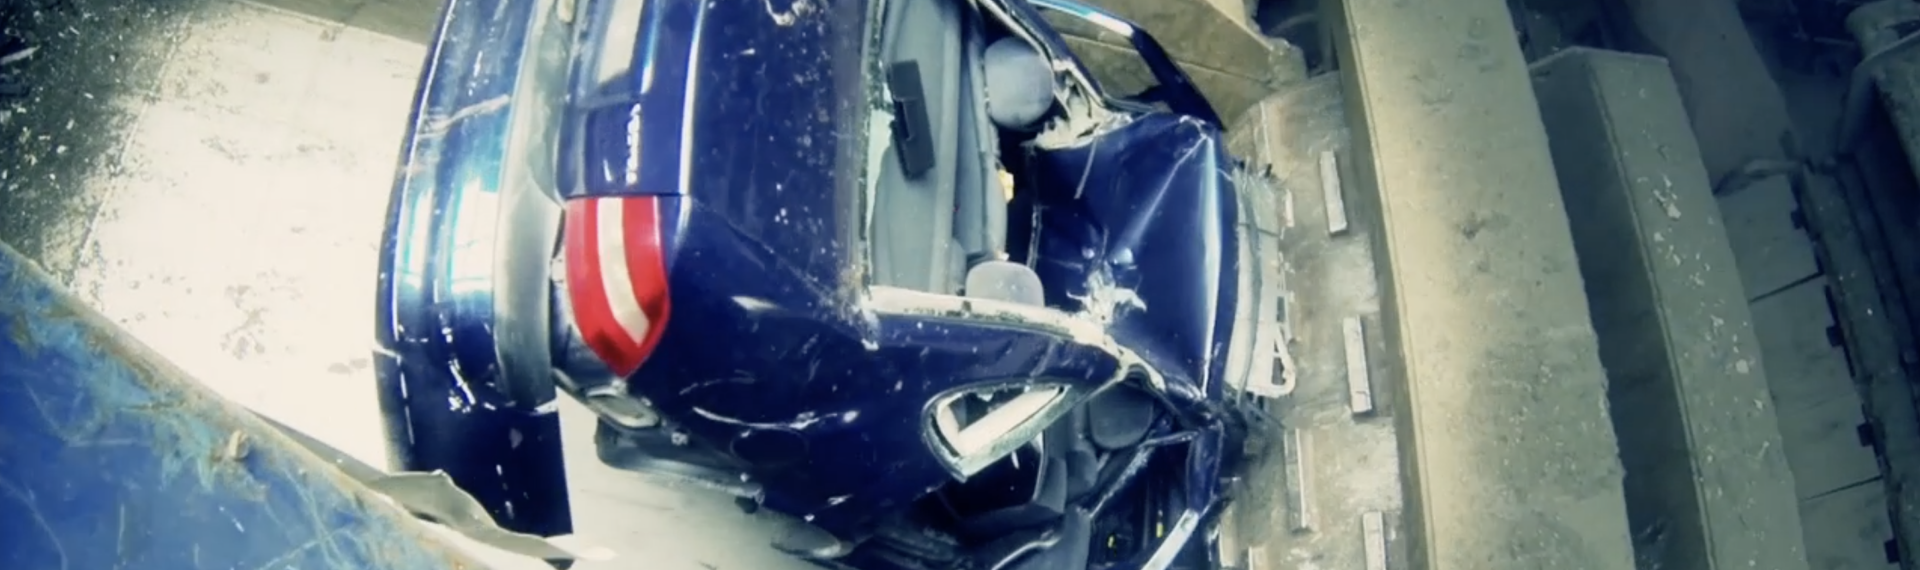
[868,0,1058,303]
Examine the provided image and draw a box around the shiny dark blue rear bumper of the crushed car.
[374,0,572,535]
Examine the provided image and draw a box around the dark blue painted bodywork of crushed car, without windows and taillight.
[378,0,1274,568]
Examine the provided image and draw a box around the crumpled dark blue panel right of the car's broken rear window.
[1033,113,1238,403]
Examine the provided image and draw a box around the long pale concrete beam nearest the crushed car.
[1327,0,1634,570]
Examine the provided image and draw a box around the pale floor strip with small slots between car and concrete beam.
[1221,75,1407,570]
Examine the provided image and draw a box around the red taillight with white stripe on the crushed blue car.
[564,196,672,378]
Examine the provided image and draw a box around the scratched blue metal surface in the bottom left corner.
[0,246,482,570]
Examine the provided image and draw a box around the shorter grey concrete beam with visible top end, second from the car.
[1534,48,1807,568]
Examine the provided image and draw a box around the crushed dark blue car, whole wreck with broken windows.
[378,0,1271,568]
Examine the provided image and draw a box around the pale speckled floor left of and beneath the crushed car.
[0,0,812,570]
